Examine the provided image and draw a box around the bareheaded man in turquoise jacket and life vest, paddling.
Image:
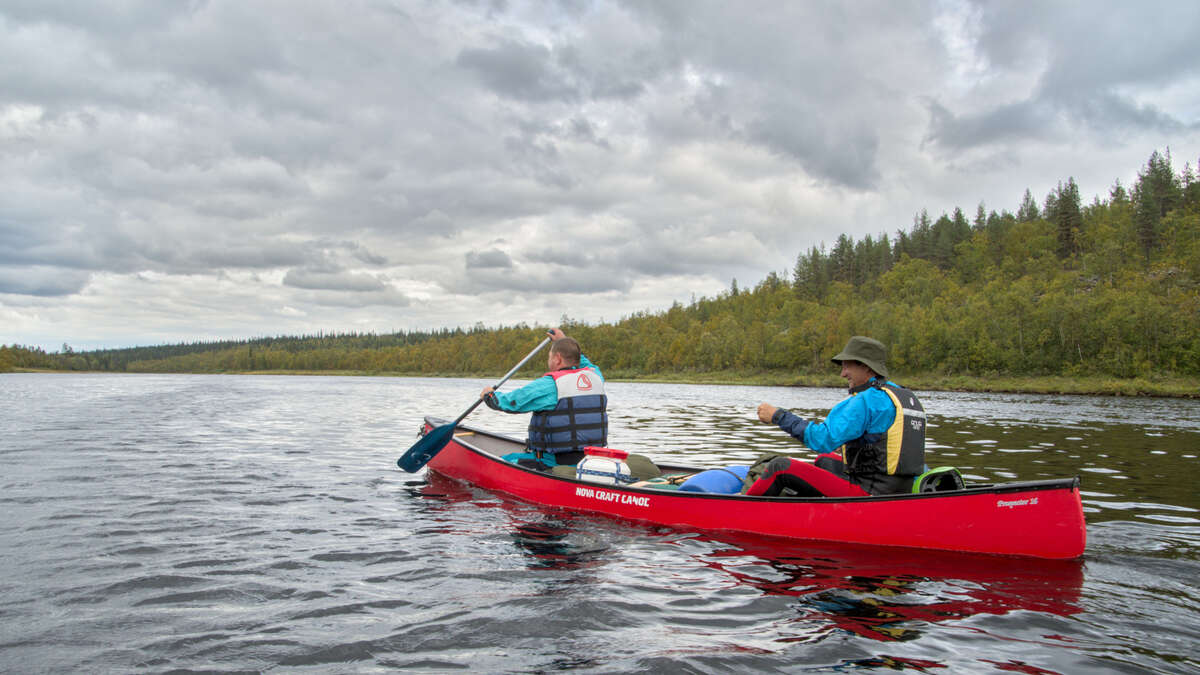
[480,328,608,470]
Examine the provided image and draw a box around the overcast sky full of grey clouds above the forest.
[0,0,1200,351]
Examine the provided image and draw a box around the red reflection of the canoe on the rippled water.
[417,473,1084,641]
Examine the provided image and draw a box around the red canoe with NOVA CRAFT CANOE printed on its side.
[425,418,1087,558]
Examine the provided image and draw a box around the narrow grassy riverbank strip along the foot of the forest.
[13,369,1200,399]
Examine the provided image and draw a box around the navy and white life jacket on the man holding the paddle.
[526,368,608,454]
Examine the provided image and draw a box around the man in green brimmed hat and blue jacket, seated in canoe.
[746,335,925,496]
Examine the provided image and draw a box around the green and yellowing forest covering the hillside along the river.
[0,145,1200,389]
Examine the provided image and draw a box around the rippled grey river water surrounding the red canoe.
[0,374,1200,673]
